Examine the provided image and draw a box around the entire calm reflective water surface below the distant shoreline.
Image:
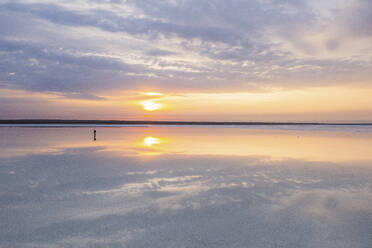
[0,126,372,248]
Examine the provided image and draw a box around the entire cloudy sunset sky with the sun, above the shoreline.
[0,0,372,122]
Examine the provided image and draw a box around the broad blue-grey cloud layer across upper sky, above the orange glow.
[0,0,372,98]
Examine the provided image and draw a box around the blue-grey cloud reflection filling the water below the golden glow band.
[0,127,372,248]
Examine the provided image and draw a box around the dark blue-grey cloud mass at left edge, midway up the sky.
[0,37,128,92]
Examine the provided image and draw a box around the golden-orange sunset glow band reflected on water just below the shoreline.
[0,126,372,165]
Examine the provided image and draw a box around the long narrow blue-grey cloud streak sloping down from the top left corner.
[2,3,241,41]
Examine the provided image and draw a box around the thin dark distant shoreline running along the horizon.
[0,119,372,126]
